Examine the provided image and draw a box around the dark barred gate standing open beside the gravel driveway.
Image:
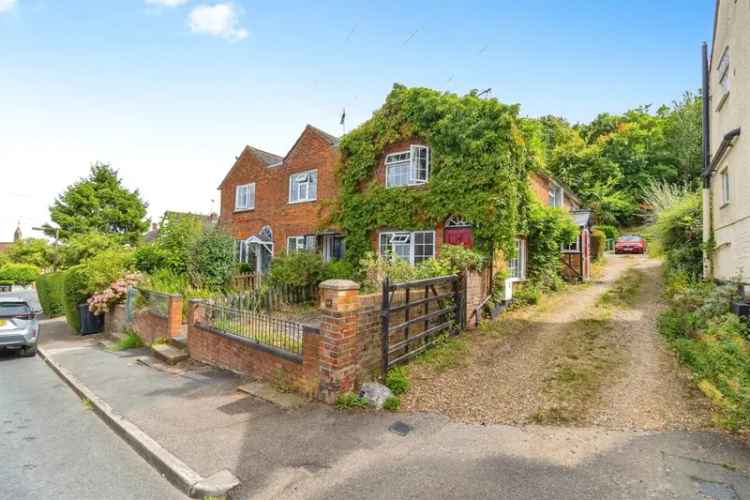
[381,274,465,375]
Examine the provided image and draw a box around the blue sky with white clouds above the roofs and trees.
[0,0,714,241]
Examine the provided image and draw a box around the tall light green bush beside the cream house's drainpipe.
[655,193,703,277]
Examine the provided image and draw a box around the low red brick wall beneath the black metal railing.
[187,301,320,398]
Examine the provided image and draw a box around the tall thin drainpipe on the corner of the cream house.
[701,42,714,279]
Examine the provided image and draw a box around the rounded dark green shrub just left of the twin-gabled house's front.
[187,228,235,290]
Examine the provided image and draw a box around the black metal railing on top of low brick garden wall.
[201,302,303,360]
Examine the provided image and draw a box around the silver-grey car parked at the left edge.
[0,297,39,357]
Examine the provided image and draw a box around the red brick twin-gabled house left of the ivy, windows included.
[219,125,345,273]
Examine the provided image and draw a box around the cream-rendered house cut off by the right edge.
[703,0,750,292]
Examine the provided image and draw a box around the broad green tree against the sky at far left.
[46,163,148,243]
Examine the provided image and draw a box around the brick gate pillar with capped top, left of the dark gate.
[318,280,360,403]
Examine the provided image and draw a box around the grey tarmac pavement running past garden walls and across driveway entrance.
[32,320,750,500]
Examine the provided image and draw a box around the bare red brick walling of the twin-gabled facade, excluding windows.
[220,127,338,255]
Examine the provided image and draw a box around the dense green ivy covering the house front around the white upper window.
[333,85,536,264]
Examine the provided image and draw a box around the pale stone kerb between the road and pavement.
[37,348,240,498]
